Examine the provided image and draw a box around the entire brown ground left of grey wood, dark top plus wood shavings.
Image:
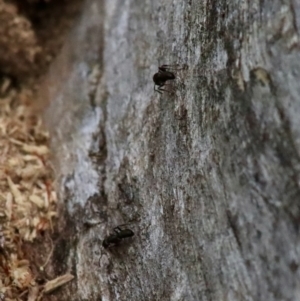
[0,0,83,300]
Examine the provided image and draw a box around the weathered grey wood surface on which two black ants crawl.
[46,0,300,301]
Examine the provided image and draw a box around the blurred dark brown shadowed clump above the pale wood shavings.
[0,0,83,81]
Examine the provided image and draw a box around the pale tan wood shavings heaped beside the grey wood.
[0,80,57,301]
